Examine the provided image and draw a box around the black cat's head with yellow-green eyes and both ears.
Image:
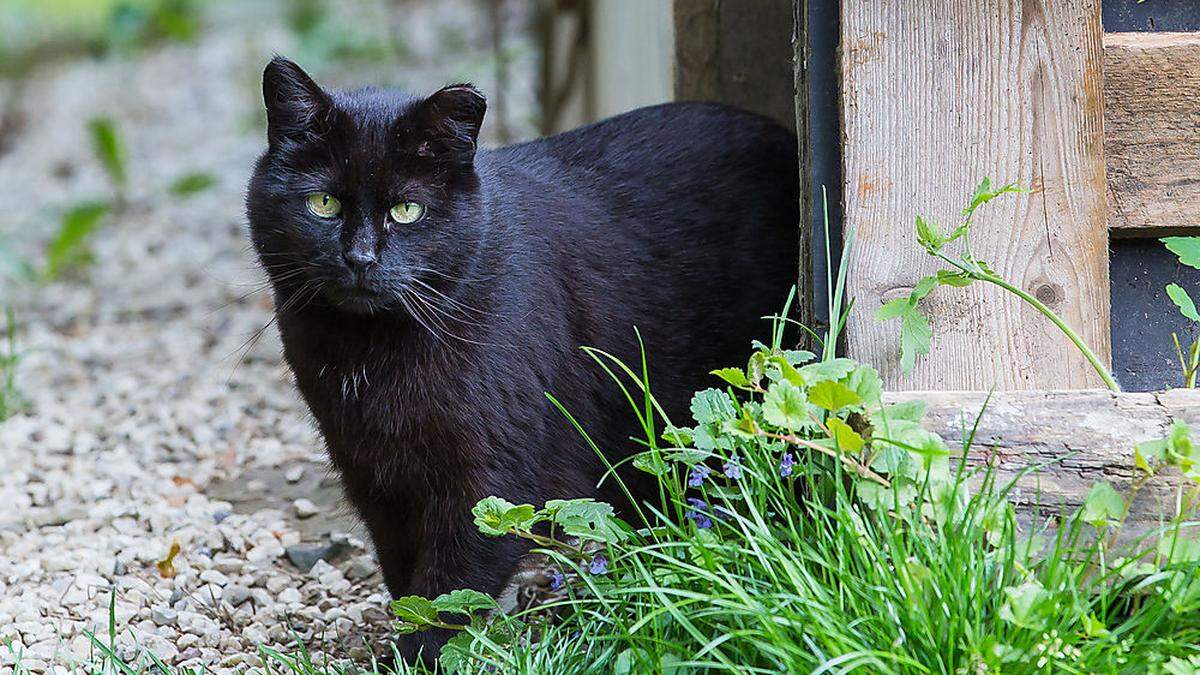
[246,56,487,313]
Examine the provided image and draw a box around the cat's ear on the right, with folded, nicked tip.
[416,84,487,168]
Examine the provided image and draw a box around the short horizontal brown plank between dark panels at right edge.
[1104,32,1200,237]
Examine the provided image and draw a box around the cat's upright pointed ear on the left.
[263,56,334,147]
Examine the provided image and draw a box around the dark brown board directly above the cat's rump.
[674,0,796,129]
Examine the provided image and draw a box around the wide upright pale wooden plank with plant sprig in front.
[841,0,1110,389]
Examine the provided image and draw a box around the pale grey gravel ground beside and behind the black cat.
[0,0,535,673]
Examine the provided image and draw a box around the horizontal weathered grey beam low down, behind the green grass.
[888,389,1200,536]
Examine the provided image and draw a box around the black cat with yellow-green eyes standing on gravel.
[246,58,799,653]
